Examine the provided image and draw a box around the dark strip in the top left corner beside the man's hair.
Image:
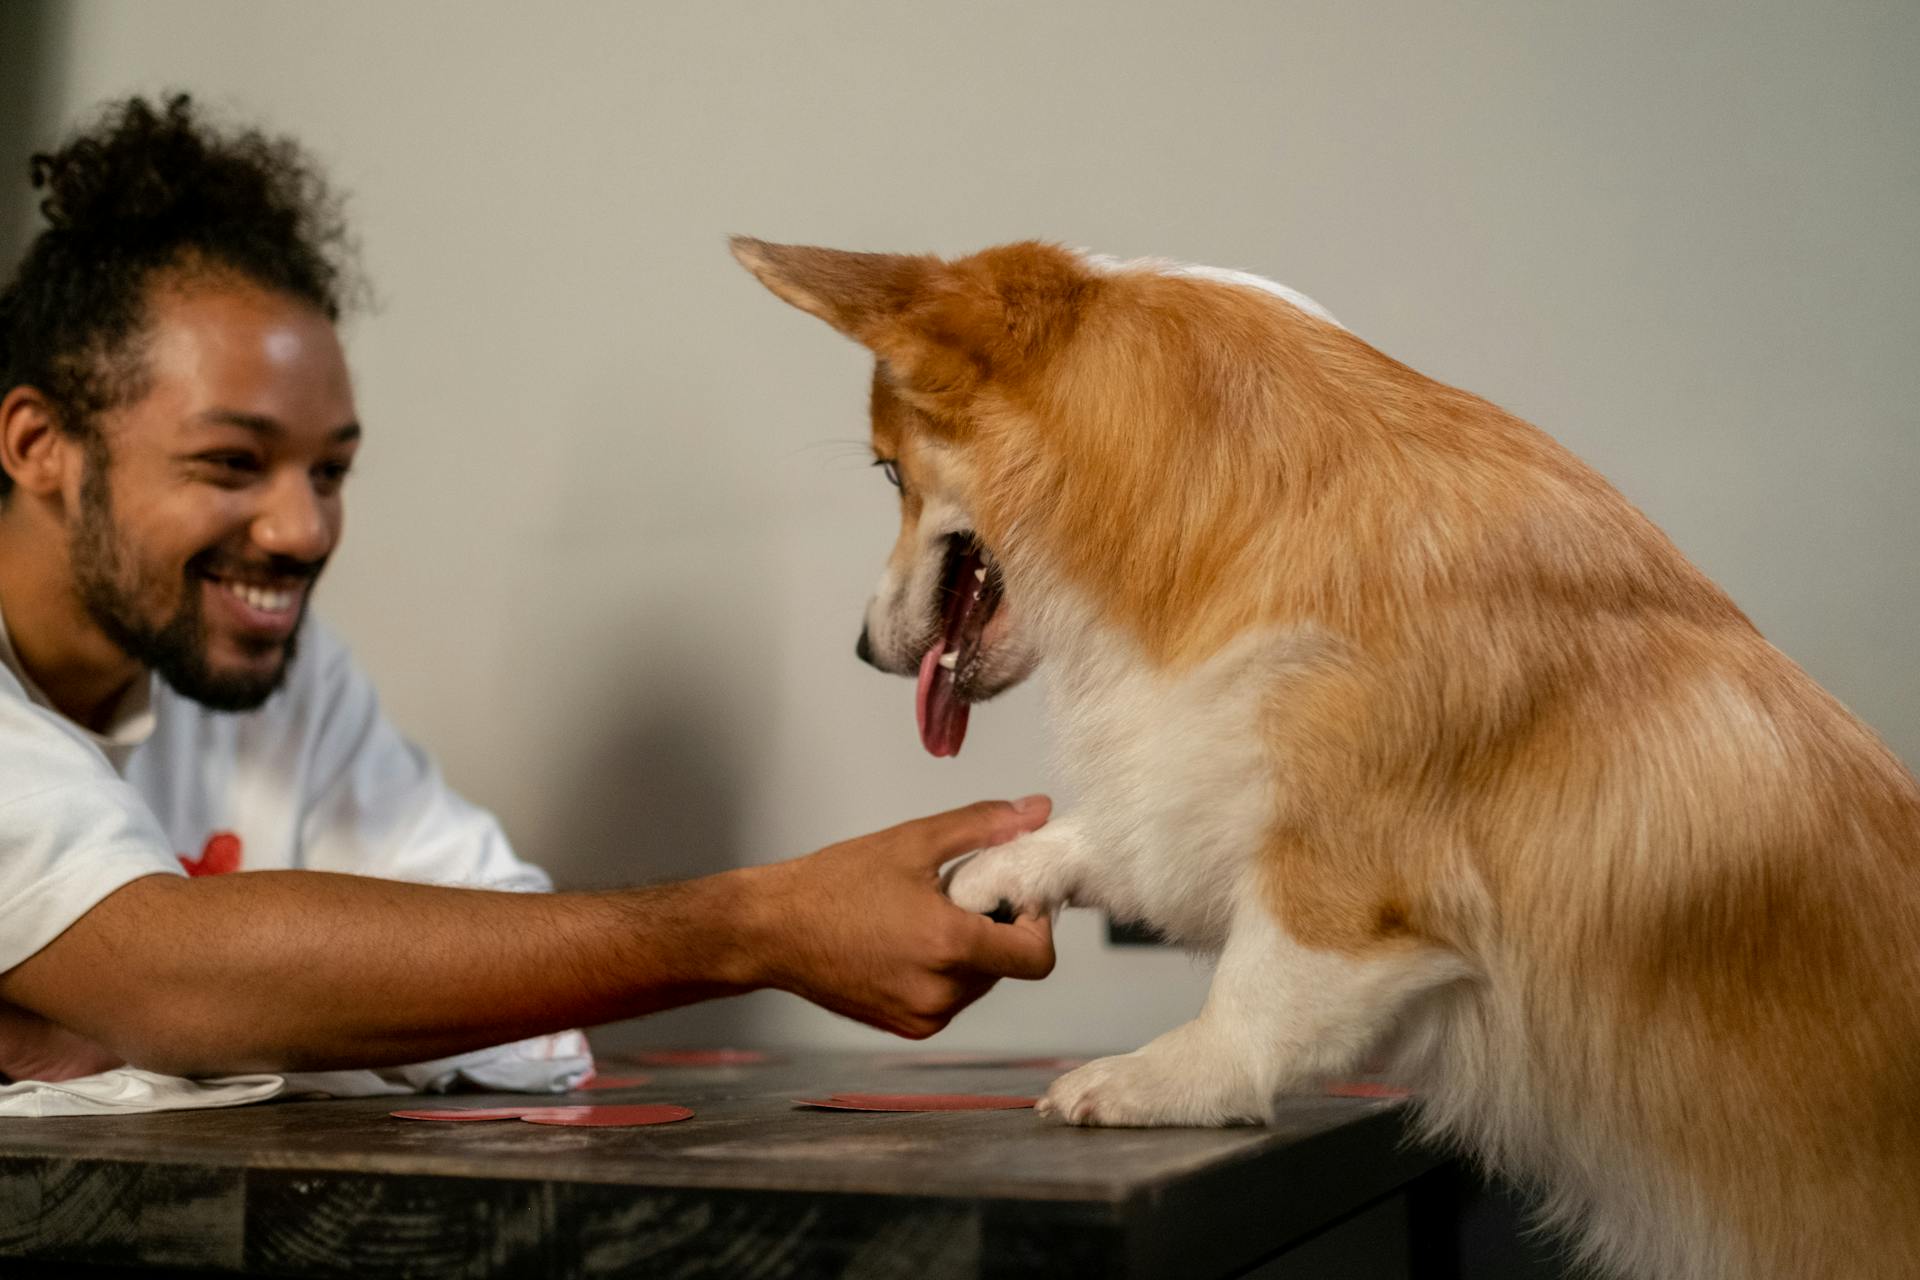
[0,0,67,266]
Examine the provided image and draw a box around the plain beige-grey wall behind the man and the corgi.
[4,0,1920,1048]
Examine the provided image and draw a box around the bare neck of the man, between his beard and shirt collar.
[0,503,146,733]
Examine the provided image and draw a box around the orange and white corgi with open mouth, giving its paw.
[733,238,1920,1280]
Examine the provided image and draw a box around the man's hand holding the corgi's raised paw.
[743,796,1054,1040]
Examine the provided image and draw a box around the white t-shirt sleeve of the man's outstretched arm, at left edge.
[0,689,184,973]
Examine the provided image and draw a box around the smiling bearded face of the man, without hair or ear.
[71,276,359,710]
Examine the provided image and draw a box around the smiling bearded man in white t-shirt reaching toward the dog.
[0,98,1052,1088]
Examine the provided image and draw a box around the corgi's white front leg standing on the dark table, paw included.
[1039,896,1467,1126]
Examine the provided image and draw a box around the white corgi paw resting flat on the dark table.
[1035,1040,1271,1128]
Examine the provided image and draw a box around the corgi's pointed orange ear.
[732,236,1087,399]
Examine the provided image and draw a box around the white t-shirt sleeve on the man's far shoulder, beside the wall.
[300,626,553,892]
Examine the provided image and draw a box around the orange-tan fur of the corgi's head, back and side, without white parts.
[737,242,1920,1280]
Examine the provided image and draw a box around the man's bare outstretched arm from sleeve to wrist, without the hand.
[0,871,762,1075]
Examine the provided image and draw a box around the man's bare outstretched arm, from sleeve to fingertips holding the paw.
[0,798,1054,1075]
